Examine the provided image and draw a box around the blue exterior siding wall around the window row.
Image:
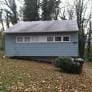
[5,32,78,56]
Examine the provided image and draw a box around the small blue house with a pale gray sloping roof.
[4,20,78,57]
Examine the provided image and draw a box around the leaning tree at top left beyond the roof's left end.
[0,0,18,27]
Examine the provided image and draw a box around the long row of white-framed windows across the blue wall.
[16,35,71,43]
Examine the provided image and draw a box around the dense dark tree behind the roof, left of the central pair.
[23,0,40,21]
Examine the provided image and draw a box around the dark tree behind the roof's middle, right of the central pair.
[41,0,60,20]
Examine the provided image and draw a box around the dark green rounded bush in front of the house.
[54,57,81,73]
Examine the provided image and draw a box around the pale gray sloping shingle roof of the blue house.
[4,20,78,33]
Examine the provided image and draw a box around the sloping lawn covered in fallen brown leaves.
[0,57,92,92]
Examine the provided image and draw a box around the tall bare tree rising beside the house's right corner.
[64,0,92,57]
